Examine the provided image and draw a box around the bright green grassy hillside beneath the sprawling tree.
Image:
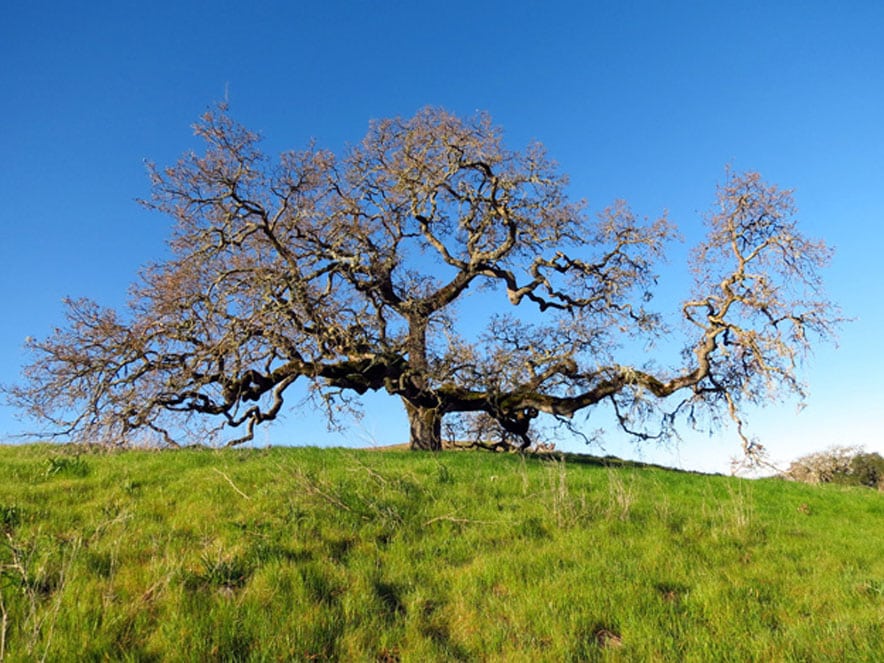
[0,445,884,662]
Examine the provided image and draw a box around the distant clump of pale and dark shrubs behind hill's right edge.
[782,447,884,490]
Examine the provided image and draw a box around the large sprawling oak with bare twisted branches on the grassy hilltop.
[5,107,837,452]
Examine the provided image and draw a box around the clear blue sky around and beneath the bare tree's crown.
[0,0,884,471]
